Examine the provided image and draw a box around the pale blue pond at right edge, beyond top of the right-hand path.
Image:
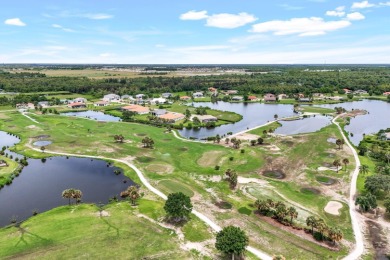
[319,99,390,145]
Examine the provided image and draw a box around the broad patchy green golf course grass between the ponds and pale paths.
[0,110,353,259]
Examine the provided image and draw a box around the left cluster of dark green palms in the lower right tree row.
[255,199,298,225]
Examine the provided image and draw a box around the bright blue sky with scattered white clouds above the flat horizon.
[0,0,390,64]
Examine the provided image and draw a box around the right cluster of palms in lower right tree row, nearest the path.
[306,216,343,244]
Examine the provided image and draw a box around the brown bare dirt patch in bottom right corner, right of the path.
[366,220,390,260]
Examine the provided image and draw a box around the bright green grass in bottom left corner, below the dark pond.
[0,203,189,259]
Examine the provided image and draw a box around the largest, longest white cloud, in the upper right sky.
[251,17,351,36]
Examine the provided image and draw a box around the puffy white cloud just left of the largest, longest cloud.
[206,13,257,29]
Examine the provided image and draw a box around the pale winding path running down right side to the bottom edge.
[332,115,364,260]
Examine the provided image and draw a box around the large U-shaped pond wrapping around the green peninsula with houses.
[179,102,296,139]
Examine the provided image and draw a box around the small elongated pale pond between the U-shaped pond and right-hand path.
[275,115,332,135]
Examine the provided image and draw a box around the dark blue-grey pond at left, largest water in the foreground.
[0,131,134,226]
